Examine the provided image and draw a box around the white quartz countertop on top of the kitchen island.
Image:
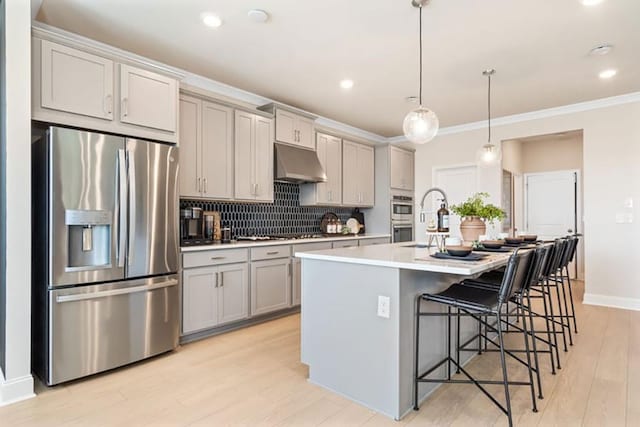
[295,242,510,275]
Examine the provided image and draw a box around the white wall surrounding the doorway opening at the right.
[416,96,640,310]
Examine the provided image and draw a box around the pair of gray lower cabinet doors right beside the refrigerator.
[182,263,249,334]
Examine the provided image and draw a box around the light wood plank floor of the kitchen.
[0,283,640,426]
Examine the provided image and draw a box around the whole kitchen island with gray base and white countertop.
[295,242,509,420]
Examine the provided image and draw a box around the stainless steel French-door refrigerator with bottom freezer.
[32,125,179,385]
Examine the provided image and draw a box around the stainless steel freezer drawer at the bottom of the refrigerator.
[43,275,179,385]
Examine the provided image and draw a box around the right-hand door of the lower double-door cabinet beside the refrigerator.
[218,264,249,324]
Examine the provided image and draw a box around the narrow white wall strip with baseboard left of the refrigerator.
[0,0,33,405]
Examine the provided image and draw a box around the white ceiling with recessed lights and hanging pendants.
[36,0,640,136]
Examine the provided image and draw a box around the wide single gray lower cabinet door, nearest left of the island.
[251,258,291,315]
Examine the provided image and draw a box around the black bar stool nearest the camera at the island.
[414,249,537,426]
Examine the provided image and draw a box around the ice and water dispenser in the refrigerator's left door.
[65,210,113,270]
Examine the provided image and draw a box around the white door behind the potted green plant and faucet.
[432,166,478,237]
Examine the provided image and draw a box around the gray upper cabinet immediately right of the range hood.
[300,132,342,206]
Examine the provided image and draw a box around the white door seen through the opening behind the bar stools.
[523,171,581,277]
